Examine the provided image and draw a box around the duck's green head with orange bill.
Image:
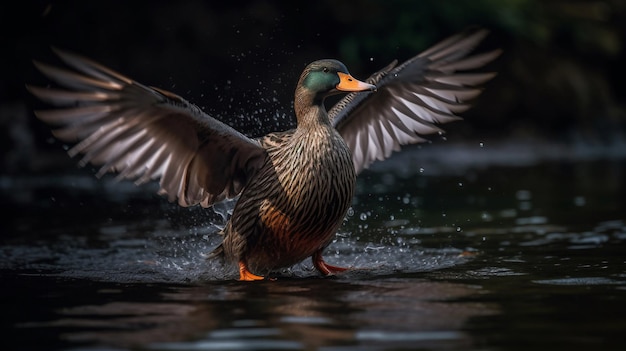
[298,59,376,99]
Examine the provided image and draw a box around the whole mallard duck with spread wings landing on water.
[28,30,499,281]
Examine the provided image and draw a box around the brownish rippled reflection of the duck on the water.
[4,277,497,350]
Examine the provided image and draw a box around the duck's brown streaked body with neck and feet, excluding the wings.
[218,60,360,279]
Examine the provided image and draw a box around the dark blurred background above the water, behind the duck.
[0,0,626,175]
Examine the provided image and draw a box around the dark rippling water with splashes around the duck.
[0,145,626,350]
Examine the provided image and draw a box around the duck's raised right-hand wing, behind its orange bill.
[328,30,500,173]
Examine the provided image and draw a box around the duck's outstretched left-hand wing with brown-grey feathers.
[27,50,266,207]
